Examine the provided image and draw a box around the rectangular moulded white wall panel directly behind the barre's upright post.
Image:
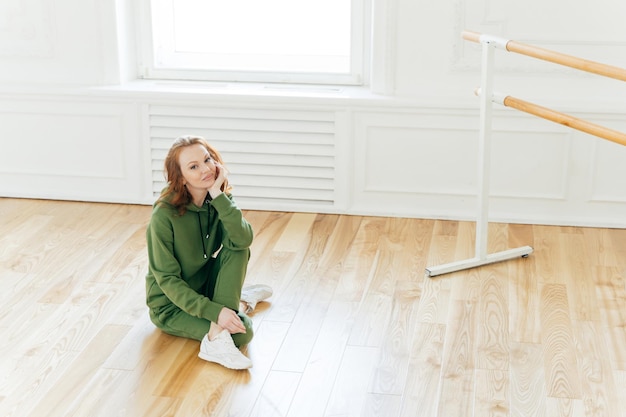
[355,112,571,200]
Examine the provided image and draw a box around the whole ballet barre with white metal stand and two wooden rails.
[426,31,626,277]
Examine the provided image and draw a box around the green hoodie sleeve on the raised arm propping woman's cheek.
[211,193,254,250]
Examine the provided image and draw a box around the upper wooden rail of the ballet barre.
[463,31,626,81]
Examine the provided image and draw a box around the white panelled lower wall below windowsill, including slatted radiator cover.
[0,89,626,227]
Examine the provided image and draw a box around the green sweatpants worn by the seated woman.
[150,247,253,347]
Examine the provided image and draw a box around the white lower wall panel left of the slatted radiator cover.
[0,96,146,203]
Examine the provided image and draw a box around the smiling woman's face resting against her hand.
[178,143,217,195]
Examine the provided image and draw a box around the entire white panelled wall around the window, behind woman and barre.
[0,0,626,227]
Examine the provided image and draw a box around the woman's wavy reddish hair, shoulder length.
[157,135,231,215]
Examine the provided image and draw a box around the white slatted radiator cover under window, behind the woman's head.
[149,106,335,210]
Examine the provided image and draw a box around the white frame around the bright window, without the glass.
[138,0,371,86]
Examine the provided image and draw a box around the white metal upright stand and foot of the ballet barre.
[426,35,533,277]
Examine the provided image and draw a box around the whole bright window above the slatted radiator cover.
[141,0,366,84]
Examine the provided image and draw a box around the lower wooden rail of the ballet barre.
[502,96,626,146]
